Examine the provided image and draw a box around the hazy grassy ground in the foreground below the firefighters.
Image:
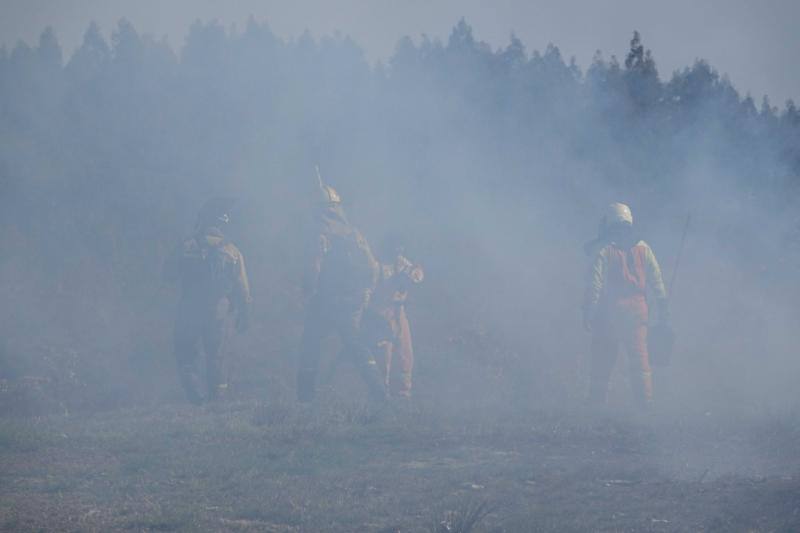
[0,388,800,532]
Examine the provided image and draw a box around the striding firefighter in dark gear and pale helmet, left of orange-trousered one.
[297,179,385,403]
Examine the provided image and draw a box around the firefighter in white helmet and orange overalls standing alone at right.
[583,203,669,407]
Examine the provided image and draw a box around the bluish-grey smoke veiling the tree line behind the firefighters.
[0,16,800,416]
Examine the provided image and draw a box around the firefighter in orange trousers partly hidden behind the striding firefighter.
[368,236,425,398]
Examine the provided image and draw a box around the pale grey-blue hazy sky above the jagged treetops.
[0,0,800,107]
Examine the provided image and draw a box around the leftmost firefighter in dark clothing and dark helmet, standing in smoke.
[164,198,251,404]
